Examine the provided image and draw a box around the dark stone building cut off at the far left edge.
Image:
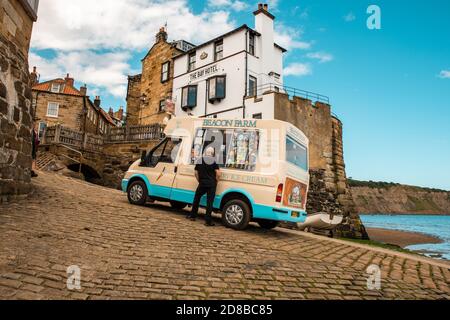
[0,0,39,202]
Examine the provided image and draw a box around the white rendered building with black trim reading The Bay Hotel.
[172,4,286,119]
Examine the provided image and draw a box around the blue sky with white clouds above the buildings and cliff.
[30,0,450,190]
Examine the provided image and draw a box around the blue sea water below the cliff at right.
[361,214,450,260]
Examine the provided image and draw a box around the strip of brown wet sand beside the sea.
[367,228,443,248]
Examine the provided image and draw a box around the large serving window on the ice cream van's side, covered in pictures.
[191,129,259,171]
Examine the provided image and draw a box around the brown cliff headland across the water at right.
[349,180,450,214]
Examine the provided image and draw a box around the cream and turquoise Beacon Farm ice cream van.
[122,118,309,230]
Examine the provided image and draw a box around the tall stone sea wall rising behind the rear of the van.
[275,93,367,238]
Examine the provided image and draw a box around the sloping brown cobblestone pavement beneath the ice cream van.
[0,173,450,299]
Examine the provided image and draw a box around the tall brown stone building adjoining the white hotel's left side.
[127,28,193,125]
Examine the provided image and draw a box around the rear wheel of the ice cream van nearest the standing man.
[222,199,252,230]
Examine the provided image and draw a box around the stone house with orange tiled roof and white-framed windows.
[31,72,116,135]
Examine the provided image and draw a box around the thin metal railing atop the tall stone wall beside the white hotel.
[247,83,330,104]
